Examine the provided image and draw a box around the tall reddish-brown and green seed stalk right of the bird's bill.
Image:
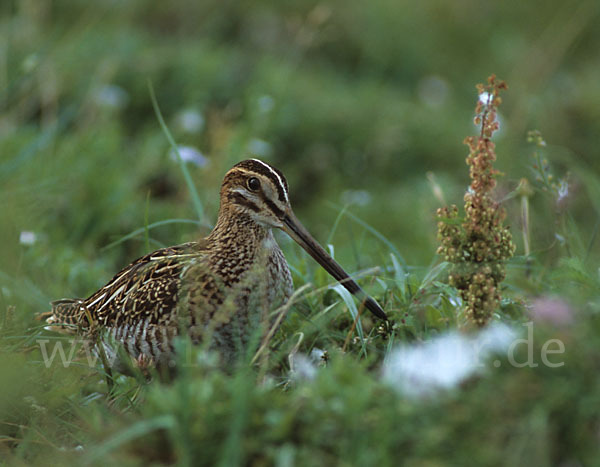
[437,75,515,326]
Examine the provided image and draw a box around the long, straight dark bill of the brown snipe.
[283,212,388,321]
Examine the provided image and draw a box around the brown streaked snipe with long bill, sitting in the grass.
[40,159,387,370]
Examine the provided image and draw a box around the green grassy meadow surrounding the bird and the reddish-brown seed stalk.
[0,0,600,466]
